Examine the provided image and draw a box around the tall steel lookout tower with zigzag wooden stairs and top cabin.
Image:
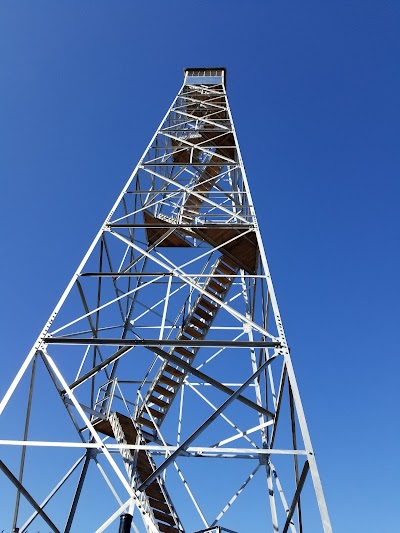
[0,68,332,533]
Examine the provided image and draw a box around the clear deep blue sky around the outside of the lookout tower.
[0,0,400,533]
